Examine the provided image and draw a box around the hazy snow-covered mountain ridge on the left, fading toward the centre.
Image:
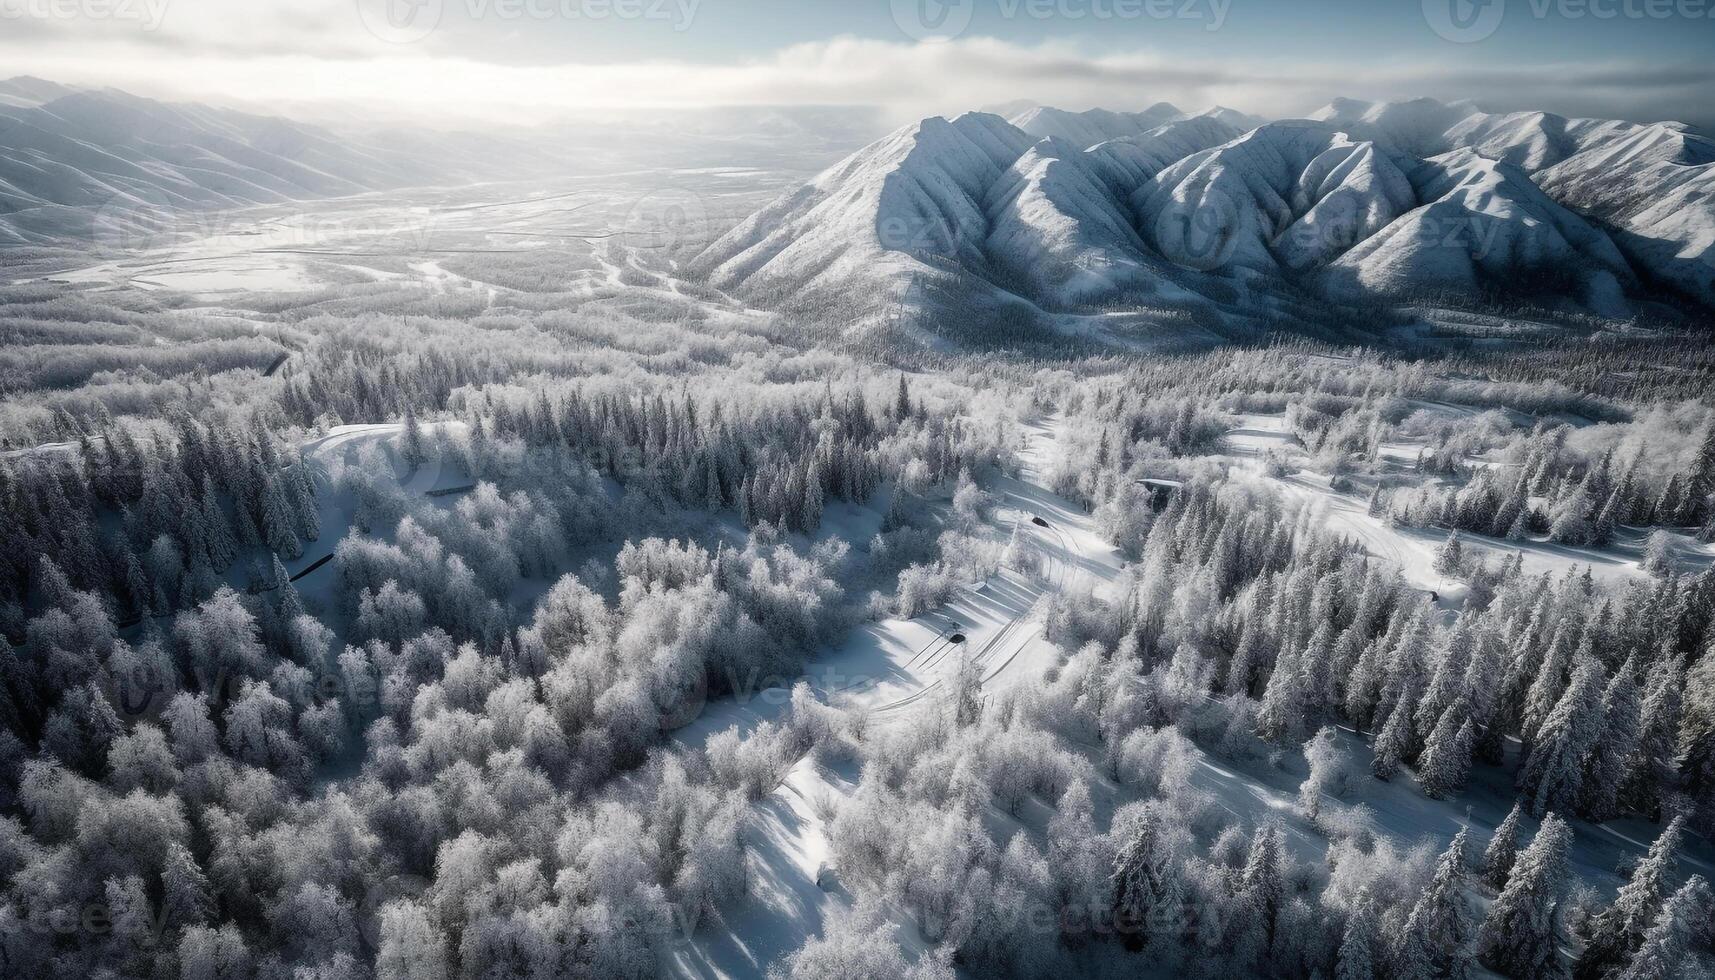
[0,77,880,245]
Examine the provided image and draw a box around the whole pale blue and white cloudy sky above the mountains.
[0,0,1715,127]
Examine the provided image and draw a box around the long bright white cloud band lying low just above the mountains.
[0,22,1715,127]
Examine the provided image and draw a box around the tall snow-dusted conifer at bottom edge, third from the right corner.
[1477,814,1573,980]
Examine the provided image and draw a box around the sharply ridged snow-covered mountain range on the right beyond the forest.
[691,100,1715,341]
